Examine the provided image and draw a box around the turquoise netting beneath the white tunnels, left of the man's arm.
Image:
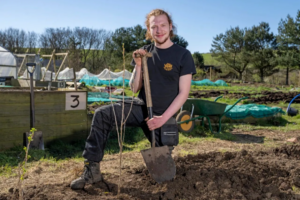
[79,74,129,87]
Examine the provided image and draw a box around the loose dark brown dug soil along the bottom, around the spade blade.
[0,145,300,200]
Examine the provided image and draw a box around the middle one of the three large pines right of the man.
[246,22,278,82]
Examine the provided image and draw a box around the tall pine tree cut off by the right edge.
[276,10,300,85]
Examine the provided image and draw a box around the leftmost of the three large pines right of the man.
[210,27,250,79]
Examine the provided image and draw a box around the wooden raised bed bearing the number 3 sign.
[0,90,90,150]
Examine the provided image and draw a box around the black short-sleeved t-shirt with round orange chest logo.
[131,44,196,115]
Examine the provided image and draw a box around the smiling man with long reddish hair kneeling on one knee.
[71,9,196,189]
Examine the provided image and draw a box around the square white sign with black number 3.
[66,92,86,110]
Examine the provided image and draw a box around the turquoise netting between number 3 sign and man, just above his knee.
[88,92,131,104]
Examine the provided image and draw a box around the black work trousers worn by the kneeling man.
[83,99,163,162]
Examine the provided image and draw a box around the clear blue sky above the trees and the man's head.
[0,0,300,53]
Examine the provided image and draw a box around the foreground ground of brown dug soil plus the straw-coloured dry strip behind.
[0,130,300,200]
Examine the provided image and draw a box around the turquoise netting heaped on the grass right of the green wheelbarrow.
[225,104,285,119]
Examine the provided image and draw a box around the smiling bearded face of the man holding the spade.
[148,15,172,44]
